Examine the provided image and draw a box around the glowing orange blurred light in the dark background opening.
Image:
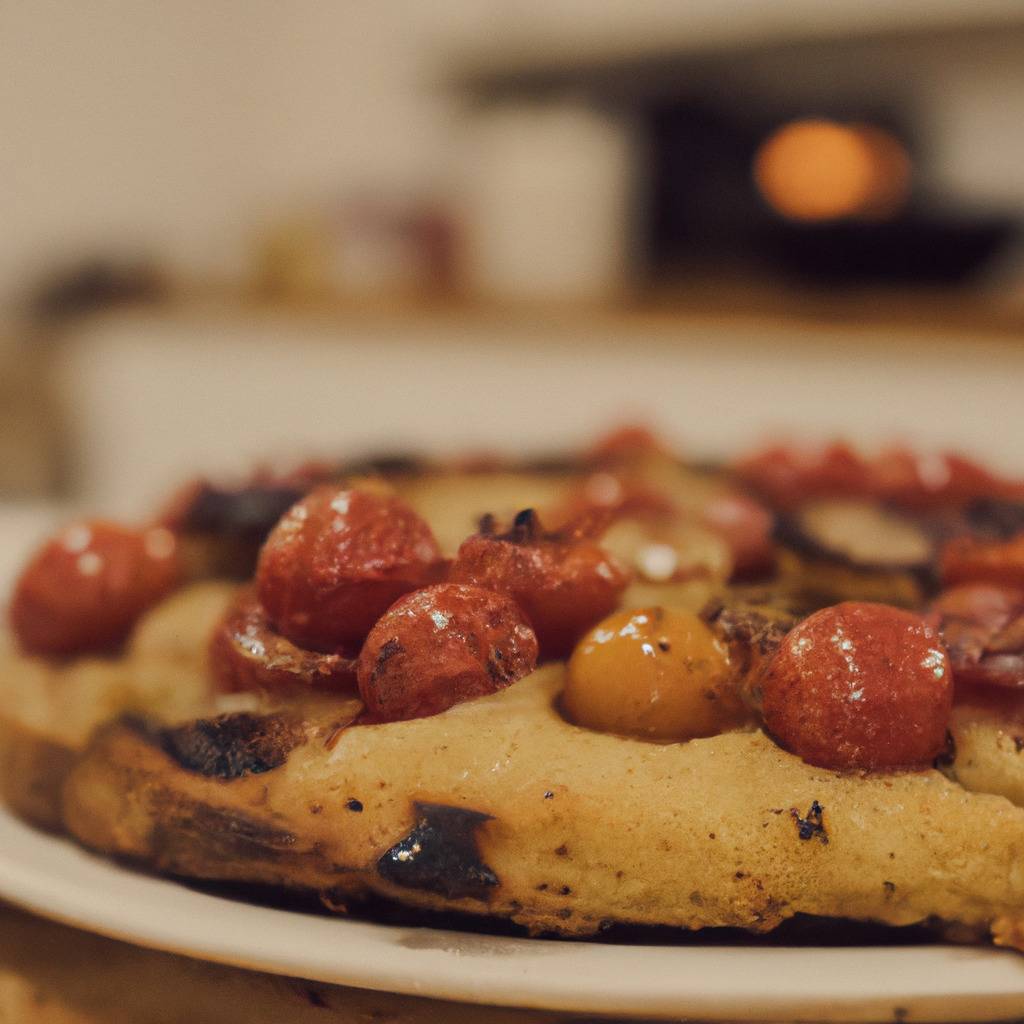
[754,119,910,220]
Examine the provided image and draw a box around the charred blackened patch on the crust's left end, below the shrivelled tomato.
[158,712,306,779]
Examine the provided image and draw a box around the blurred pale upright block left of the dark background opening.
[461,99,637,302]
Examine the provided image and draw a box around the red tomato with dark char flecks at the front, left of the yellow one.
[356,583,538,722]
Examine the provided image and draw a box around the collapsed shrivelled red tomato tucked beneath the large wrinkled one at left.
[210,590,355,693]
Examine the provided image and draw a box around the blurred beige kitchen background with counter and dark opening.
[0,0,1024,520]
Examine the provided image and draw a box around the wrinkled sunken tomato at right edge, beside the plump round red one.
[929,583,1024,689]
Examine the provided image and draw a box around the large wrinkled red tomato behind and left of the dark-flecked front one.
[256,485,442,652]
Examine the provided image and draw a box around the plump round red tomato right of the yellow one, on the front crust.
[762,601,953,770]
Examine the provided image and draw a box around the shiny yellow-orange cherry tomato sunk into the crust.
[562,606,745,741]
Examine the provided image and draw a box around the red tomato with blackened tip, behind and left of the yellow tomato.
[450,509,629,657]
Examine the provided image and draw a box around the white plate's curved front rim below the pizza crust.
[0,809,1024,1021]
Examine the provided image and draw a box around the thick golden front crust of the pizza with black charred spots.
[65,667,1024,935]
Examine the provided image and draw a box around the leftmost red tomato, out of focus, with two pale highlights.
[10,521,179,656]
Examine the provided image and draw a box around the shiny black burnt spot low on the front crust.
[377,803,500,900]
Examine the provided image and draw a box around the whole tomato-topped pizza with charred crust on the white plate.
[6,428,1024,947]
